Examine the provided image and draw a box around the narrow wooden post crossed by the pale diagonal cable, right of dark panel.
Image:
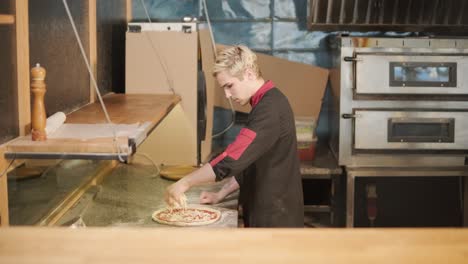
[88,0,98,103]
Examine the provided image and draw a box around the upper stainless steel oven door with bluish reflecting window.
[352,53,468,95]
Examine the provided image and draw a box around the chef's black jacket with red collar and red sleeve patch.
[210,81,304,227]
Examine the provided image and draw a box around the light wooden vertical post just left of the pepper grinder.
[15,0,31,136]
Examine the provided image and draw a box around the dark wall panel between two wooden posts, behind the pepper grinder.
[29,0,90,115]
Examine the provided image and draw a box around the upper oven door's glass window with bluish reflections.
[390,62,457,87]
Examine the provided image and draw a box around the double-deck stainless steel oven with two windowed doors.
[332,37,468,167]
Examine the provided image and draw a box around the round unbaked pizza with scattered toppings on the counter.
[153,206,221,226]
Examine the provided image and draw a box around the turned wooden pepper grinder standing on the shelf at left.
[31,63,47,141]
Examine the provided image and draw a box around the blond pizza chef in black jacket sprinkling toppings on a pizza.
[165,45,304,227]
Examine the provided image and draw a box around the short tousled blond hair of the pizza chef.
[213,45,262,80]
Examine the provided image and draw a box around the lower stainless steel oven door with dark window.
[354,109,468,151]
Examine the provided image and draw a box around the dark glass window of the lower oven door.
[388,118,455,143]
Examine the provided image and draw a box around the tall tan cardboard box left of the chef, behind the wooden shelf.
[126,25,214,165]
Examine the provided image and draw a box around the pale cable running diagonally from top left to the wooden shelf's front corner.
[63,0,125,162]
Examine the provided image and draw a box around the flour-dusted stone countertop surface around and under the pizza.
[58,164,238,228]
